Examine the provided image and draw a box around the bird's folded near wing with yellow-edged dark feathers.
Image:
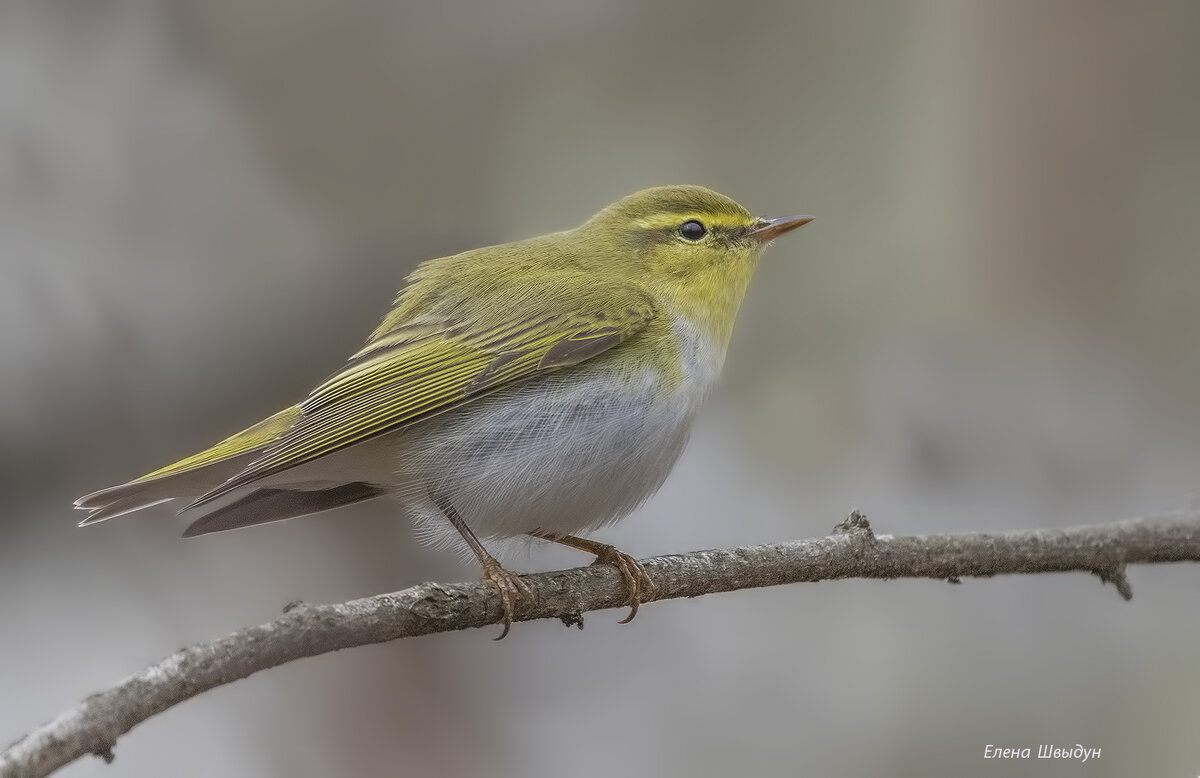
[184,277,655,510]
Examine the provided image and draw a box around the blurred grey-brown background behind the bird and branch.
[0,0,1200,778]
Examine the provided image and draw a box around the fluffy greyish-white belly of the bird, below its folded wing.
[392,372,697,537]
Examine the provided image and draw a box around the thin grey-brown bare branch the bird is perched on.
[7,511,1200,778]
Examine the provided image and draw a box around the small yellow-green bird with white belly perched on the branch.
[76,186,811,638]
